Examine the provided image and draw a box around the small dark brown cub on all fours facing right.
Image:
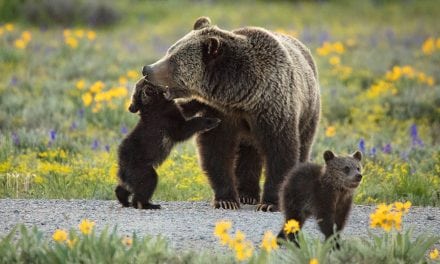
[278,150,362,243]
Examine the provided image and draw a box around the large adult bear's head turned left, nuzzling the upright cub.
[142,17,247,104]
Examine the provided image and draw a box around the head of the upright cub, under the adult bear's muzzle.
[128,78,172,113]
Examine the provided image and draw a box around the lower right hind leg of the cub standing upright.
[132,166,160,209]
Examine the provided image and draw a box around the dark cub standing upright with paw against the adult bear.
[115,79,220,209]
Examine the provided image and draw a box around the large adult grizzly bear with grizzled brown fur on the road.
[142,17,321,211]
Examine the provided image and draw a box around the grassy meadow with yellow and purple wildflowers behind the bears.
[0,0,440,206]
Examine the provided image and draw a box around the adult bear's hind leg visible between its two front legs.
[235,143,263,204]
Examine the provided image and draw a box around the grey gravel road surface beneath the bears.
[0,199,440,250]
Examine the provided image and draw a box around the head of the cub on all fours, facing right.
[324,150,362,189]
